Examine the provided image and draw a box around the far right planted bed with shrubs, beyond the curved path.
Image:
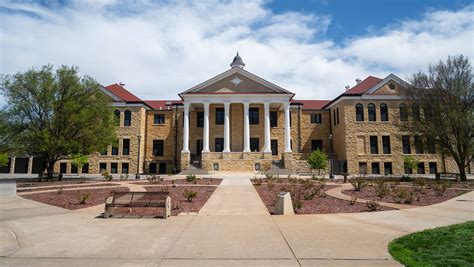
[342,183,469,206]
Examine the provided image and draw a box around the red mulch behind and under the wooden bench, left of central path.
[114,186,216,218]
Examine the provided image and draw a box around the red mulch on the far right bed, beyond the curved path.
[343,186,469,206]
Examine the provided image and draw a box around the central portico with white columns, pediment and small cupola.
[180,55,294,171]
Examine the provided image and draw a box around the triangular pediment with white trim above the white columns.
[180,67,292,95]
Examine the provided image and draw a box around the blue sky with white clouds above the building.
[0,0,474,102]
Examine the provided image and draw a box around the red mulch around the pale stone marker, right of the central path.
[254,183,391,214]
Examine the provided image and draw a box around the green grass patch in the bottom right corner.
[388,221,474,267]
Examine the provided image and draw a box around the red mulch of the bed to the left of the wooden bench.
[21,187,129,210]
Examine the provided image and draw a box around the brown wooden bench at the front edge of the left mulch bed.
[104,192,171,219]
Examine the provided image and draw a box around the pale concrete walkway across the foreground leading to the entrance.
[0,174,474,266]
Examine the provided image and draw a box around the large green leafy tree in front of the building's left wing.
[0,65,115,177]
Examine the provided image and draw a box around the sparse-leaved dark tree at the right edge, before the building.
[406,55,474,181]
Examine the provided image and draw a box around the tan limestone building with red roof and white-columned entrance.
[2,54,457,175]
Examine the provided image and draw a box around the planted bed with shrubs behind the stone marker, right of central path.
[253,179,392,214]
